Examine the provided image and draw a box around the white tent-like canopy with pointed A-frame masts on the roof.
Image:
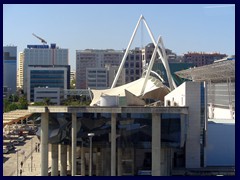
[90,15,176,106]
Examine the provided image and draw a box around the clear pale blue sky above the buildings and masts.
[3,4,235,70]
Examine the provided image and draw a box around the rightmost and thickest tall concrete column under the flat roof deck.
[152,113,161,176]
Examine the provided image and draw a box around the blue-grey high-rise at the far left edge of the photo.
[3,46,17,94]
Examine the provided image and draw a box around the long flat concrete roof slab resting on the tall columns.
[28,106,188,114]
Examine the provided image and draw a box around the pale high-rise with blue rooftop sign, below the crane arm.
[23,44,69,93]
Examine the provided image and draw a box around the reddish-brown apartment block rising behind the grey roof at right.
[183,52,227,67]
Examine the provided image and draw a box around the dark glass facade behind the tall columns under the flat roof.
[37,113,185,176]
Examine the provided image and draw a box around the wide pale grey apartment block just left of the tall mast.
[76,49,123,89]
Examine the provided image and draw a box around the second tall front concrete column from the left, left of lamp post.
[69,113,77,176]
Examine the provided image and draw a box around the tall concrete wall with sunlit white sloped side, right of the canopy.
[164,81,201,168]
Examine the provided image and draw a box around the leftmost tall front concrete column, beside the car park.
[41,112,48,176]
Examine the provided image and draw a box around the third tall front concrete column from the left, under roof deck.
[111,113,116,176]
